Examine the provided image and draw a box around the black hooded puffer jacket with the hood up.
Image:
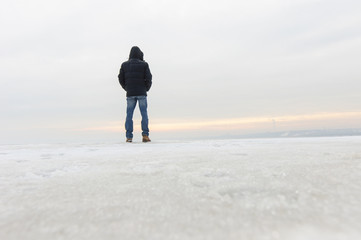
[118,47,152,97]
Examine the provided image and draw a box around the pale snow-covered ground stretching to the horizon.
[0,137,361,240]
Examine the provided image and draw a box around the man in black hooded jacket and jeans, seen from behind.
[118,46,152,142]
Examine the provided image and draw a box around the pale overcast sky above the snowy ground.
[0,0,361,143]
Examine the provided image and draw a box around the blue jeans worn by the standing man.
[125,96,149,138]
